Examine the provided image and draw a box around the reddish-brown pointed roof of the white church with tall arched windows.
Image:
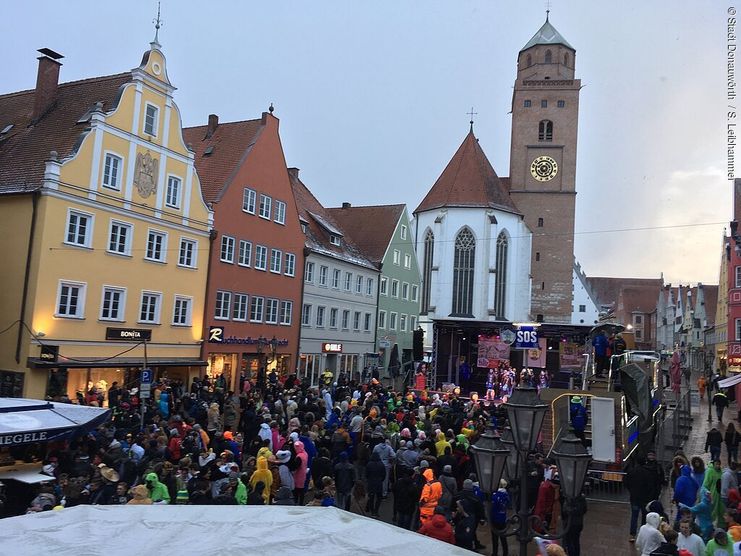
[414,131,521,214]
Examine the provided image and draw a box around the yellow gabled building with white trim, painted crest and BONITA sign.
[0,38,212,398]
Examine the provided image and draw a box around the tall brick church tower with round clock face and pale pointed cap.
[509,16,581,323]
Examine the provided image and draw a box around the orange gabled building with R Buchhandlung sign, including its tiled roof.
[183,113,305,391]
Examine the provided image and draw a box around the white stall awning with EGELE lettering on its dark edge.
[0,398,111,447]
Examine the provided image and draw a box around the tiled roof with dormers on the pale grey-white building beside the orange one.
[288,169,376,269]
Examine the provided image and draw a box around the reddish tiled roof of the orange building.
[183,119,264,203]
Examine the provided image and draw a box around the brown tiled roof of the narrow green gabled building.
[327,205,405,264]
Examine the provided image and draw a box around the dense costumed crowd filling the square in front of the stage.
[1,373,586,556]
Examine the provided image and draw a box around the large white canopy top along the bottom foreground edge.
[0,505,471,556]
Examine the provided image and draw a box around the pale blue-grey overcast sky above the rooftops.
[0,0,728,283]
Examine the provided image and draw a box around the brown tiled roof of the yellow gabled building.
[0,73,131,194]
